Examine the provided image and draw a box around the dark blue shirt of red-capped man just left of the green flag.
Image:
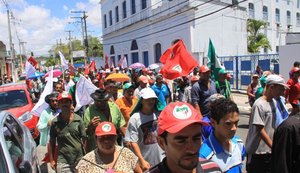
[191,80,217,115]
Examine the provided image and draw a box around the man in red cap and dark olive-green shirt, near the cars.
[48,92,86,173]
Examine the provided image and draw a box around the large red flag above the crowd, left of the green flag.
[160,40,199,80]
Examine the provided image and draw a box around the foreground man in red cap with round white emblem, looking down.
[149,102,221,173]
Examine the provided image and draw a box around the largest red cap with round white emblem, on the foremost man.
[157,102,208,135]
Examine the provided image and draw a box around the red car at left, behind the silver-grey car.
[0,83,39,141]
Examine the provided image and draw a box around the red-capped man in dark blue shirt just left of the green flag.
[191,65,217,117]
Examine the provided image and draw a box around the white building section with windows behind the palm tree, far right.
[247,0,300,53]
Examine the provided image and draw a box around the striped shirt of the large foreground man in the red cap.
[145,158,222,173]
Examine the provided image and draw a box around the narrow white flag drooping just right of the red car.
[31,69,53,117]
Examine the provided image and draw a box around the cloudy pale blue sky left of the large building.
[0,0,102,56]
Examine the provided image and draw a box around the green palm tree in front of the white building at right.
[247,19,272,53]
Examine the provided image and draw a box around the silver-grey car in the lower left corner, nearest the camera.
[0,111,40,173]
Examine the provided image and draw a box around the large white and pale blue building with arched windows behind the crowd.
[101,0,300,65]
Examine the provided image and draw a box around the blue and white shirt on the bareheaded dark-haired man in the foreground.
[200,133,245,173]
